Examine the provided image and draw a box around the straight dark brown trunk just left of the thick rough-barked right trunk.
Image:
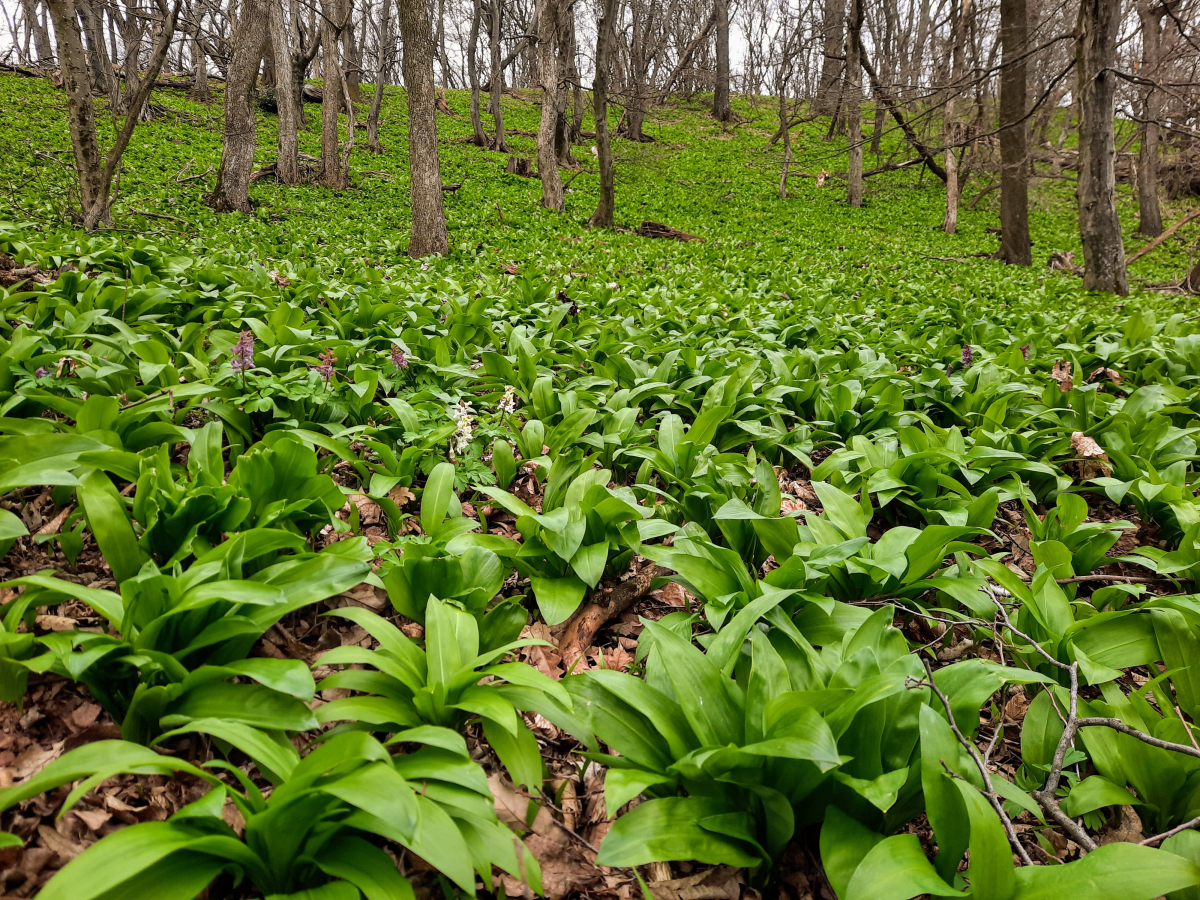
[1000,0,1033,265]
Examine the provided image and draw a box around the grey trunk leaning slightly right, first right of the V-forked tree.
[205,0,268,212]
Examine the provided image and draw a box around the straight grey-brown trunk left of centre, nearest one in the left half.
[400,0,451,257]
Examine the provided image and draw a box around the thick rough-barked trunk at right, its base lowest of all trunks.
[1075,0,1129,295]
